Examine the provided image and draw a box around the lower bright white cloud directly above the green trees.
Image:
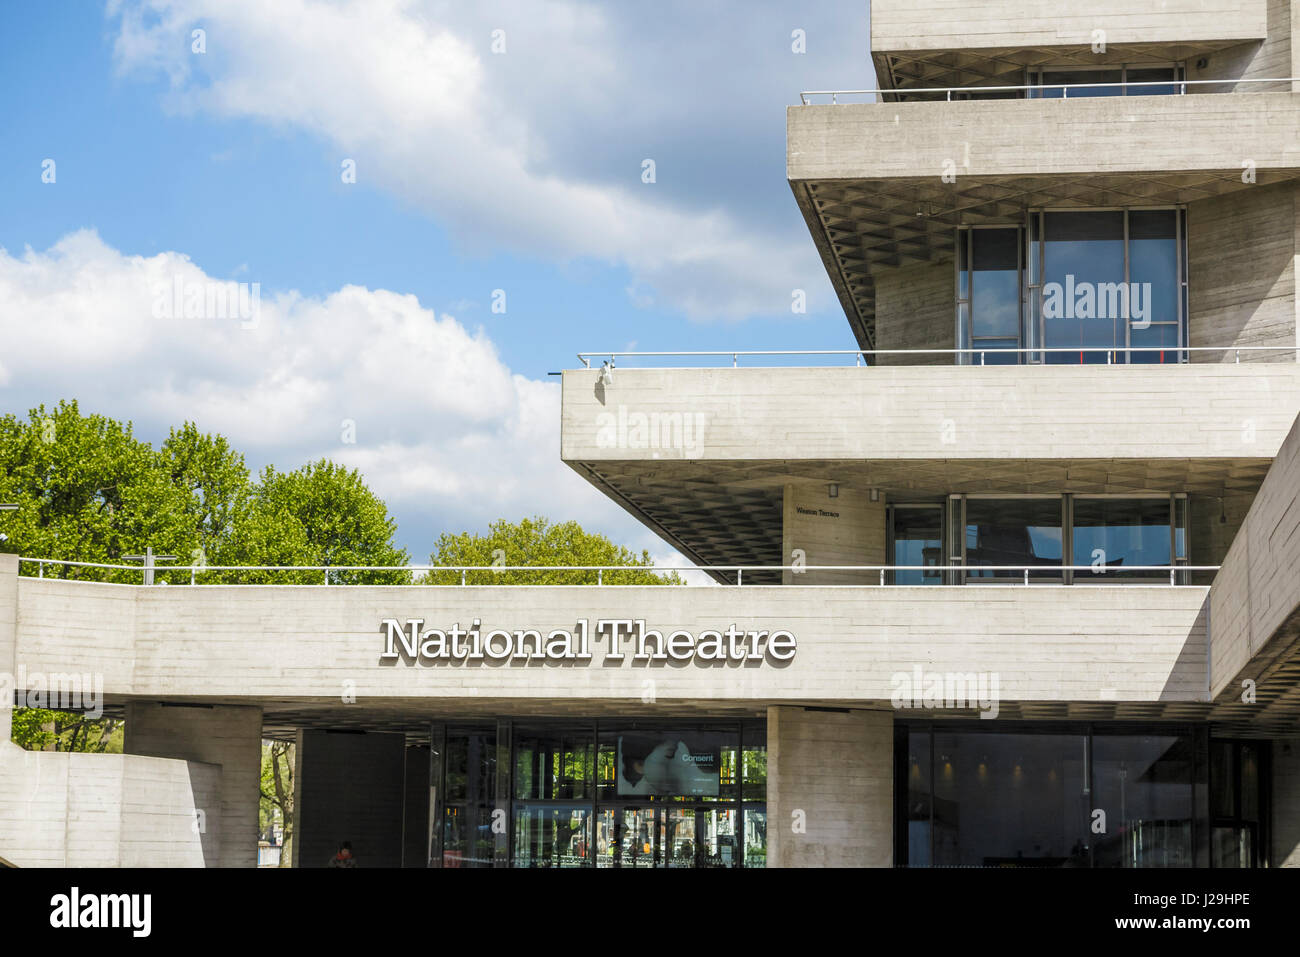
[0,230,680,562]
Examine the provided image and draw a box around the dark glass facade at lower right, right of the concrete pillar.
[894,722,1265,867]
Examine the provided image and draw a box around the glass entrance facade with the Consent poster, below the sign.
[430,719,767,867]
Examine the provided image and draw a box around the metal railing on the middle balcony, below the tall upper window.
[577,346,1300,369]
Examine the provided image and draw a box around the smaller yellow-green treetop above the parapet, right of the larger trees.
[424,516,683,585]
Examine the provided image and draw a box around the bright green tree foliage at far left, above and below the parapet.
[0,400,410,750]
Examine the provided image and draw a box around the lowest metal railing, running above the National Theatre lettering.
[18,557,1219,588]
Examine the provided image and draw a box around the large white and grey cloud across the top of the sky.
[109,0,829,317]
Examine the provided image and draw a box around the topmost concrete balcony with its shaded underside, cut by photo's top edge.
[871,0,1263,87]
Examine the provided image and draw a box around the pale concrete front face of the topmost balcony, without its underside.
[871,0,1263,52]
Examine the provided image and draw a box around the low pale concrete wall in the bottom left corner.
[0,742,222,867]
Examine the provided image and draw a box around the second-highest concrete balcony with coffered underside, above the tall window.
[787,87,1300,347]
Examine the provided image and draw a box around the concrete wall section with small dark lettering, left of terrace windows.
[781,484,885,585]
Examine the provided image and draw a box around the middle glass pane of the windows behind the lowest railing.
[966,498,1065,581]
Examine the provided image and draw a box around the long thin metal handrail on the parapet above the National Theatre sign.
[18,555,1219,588]
